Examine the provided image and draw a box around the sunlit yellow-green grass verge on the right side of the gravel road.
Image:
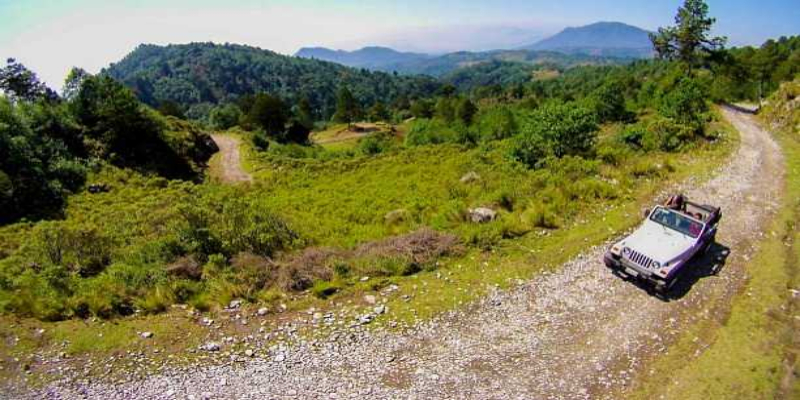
[631,103,800,399]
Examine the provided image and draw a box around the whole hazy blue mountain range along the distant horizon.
[295,22,653,76]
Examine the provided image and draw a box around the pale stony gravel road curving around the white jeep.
[21,109,783,399]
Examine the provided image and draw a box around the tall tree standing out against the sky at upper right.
[650,0,727,70]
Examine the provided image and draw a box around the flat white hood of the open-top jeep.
[620,220,697,264]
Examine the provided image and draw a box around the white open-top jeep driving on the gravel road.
[603,195,722,294]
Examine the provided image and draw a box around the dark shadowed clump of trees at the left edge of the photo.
[0,59,216,223]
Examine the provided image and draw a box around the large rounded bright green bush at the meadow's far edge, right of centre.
[512,103,597,168]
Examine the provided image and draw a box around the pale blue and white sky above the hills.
[0,0,800,88]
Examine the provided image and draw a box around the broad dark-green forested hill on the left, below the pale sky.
[103,43,439,118]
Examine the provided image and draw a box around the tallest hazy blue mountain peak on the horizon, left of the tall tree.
[523,22,653,58]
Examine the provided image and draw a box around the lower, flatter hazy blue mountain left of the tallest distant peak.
[295,46,431,70]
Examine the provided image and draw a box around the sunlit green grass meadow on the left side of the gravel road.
[0,108,735,384]
